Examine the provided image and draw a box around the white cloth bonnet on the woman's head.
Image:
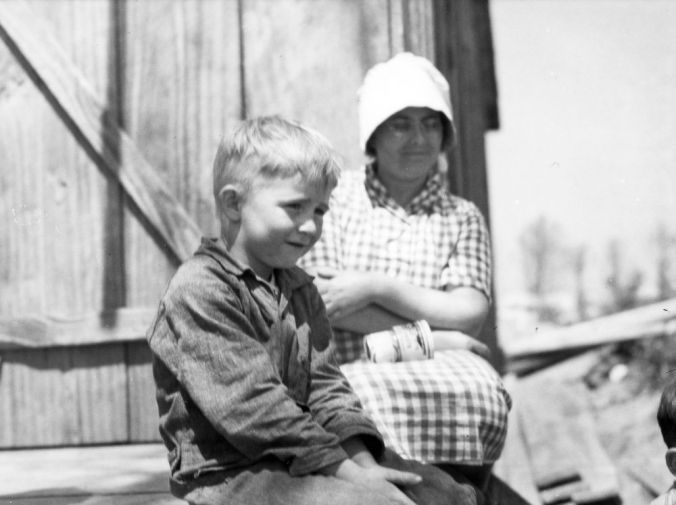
[357,53,453,151]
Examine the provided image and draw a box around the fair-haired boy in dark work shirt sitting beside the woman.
[148,117,483,505]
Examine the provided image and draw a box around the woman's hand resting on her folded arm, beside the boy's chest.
[313,268,377,321]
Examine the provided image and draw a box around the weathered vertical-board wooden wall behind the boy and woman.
[0,0,496,447]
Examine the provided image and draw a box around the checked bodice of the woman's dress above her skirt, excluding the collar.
[299,166,491,363]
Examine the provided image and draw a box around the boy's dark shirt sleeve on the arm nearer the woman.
[308,285,384,458]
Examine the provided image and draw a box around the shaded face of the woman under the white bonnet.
[370,107,444,187]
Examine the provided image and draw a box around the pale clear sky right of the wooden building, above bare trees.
[486,0,676,316]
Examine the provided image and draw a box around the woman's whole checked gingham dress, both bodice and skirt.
[300,166,511,464]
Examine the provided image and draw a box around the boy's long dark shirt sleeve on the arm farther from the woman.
[150,268,347,475]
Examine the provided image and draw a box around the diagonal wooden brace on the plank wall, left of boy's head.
[0,0,201,261]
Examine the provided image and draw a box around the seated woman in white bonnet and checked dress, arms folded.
[301,53,510,486]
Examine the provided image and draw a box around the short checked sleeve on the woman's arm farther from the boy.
[441,202,491,300]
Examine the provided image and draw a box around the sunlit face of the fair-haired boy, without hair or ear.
[230,171,331,279]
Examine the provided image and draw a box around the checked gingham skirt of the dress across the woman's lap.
[341,351,511,465]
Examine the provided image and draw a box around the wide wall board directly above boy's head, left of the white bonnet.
[243,0,374,173]
